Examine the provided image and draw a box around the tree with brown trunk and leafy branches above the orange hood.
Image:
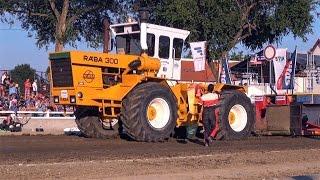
[0,0,127,52]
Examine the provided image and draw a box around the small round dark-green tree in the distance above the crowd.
[10,64,36,93]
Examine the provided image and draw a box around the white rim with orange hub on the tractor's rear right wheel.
[228,104,248,132]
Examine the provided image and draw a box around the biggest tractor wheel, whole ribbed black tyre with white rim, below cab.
[120,82,177,142]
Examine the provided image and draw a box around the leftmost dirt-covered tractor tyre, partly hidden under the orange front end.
[75,107,119,139]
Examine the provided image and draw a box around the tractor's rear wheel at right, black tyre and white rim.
[217,90,254,140]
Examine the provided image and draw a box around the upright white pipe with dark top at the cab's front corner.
[139,8,149,54]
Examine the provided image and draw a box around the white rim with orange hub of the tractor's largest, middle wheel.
[147,98,171,129]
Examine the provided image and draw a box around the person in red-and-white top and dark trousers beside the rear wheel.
[200,84,219,146]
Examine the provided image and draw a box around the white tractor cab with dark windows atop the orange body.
[110,22,190,80]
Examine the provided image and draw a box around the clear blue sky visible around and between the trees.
[0,7,320,71]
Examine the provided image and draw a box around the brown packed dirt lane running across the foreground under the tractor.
[0,136,320,179]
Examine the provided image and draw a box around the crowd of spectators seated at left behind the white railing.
[0,72,63,112]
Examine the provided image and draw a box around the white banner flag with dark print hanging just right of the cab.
[190,41,206,71]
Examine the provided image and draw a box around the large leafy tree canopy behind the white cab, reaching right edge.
[137,0,318,59]
